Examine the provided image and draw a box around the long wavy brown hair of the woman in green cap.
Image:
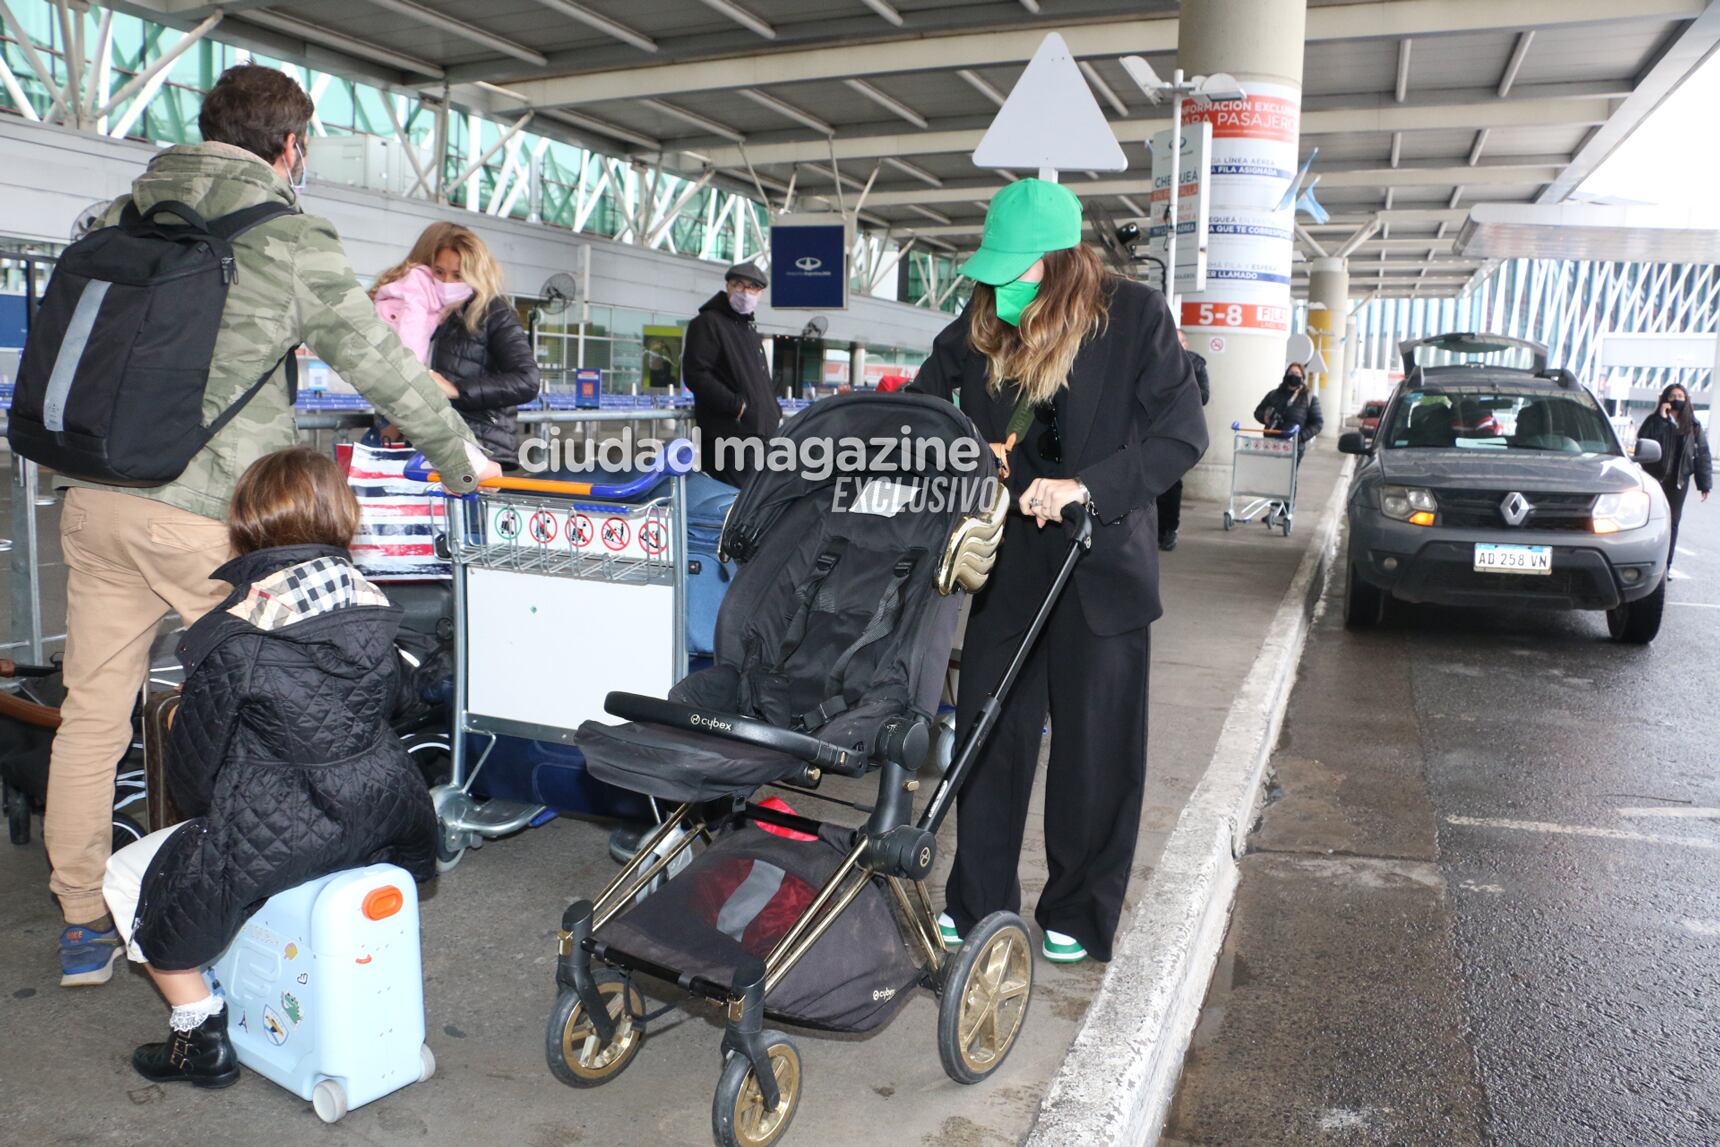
[968,244,1116,402]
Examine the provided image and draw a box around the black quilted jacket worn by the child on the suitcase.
[134,545,435,970]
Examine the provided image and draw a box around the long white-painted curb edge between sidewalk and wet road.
[1023,457,1355,1147]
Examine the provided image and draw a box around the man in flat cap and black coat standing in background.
[681,263,783,487]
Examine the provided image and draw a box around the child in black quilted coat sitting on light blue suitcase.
[101,447,437,1087]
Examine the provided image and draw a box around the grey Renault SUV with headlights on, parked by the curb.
[1338,334,1672,645]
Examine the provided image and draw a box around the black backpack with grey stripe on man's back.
[7,199,298,487]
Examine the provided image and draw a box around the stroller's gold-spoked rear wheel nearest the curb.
[937,911,1034,1083]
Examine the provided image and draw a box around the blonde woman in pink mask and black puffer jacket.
[372,224,538,469]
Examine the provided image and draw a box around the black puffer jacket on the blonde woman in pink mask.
[430,297,538,466]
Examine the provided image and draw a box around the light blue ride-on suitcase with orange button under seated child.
[205,865,435,1123]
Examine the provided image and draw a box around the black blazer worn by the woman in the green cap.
[910,279,1207,636]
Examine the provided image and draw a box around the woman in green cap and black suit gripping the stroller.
[913,179,1206,963]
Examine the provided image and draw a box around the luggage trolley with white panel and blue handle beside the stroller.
[408,453,693,872]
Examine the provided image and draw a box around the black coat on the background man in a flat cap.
[681,291,783,487]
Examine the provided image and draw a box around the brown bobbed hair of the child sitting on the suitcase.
[227,445,358,554]
